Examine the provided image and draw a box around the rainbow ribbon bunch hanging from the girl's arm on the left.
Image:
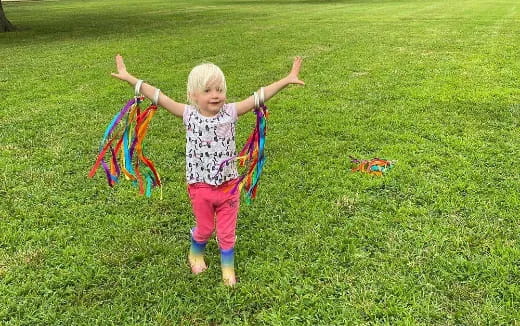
[88,96,162,197]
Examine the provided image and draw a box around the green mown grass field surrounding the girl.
[0,0,520,325]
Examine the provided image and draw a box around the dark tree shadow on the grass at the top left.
[0,4,232,45]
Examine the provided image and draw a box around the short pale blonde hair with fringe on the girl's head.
[186,62,227,104]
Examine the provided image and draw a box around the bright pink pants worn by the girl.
[188,180,240,250]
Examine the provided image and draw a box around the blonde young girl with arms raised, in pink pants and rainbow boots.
[112,55,305,286]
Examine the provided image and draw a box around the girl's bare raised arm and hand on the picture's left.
[111,54,185,117]
